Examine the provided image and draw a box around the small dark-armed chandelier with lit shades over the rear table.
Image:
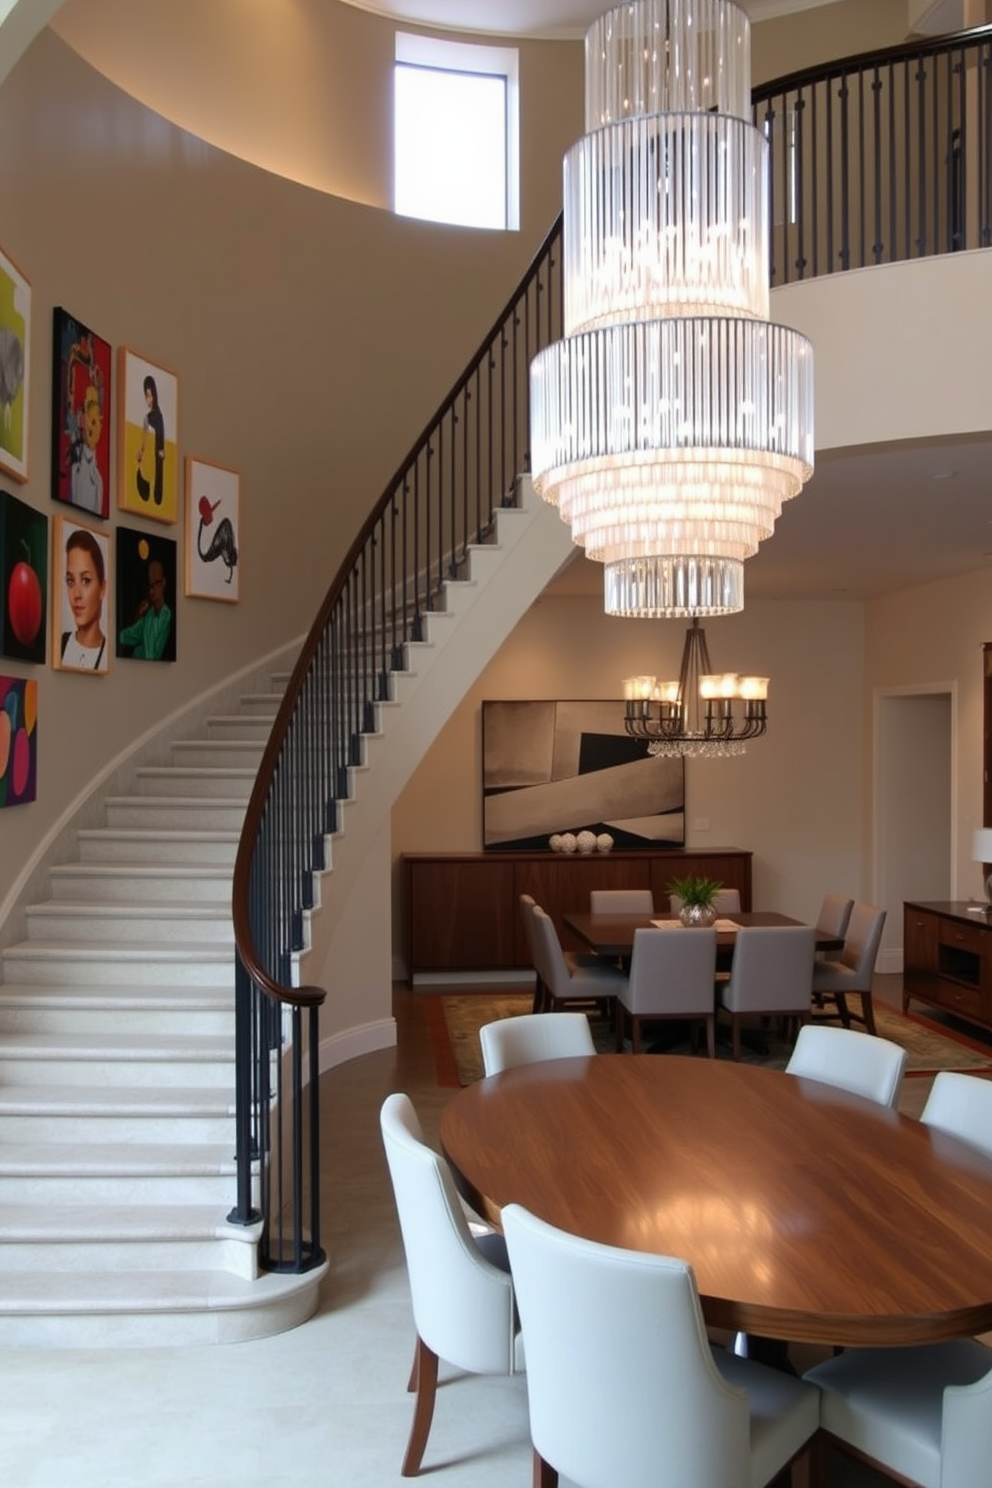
[623,618,769,759]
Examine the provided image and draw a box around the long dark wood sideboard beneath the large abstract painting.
[403,847,751,982]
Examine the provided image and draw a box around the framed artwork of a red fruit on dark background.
[0,491,48,662]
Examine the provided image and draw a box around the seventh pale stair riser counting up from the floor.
[3,942,233,991]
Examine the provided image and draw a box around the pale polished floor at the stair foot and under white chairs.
[0,979,987,1488]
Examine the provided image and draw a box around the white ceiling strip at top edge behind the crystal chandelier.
[336,0,833,40]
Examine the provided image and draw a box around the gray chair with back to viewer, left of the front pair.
[617,927,717,1059]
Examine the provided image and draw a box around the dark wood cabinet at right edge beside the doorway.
[903,900,992,1028]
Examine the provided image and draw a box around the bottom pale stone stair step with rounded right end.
[0,1262,327,1348]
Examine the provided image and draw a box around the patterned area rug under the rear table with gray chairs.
[430,991,992,1104]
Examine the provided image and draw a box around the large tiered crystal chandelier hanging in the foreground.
[531,0,814,616]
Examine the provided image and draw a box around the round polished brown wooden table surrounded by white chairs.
[440,1054,992,1345]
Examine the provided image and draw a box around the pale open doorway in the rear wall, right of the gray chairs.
[872,684,956,972]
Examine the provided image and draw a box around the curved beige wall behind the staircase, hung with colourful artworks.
[0,29,583,906]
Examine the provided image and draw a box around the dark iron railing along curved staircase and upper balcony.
[231,27,992,1271]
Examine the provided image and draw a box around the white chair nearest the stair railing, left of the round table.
[379,1094,522,1478]
